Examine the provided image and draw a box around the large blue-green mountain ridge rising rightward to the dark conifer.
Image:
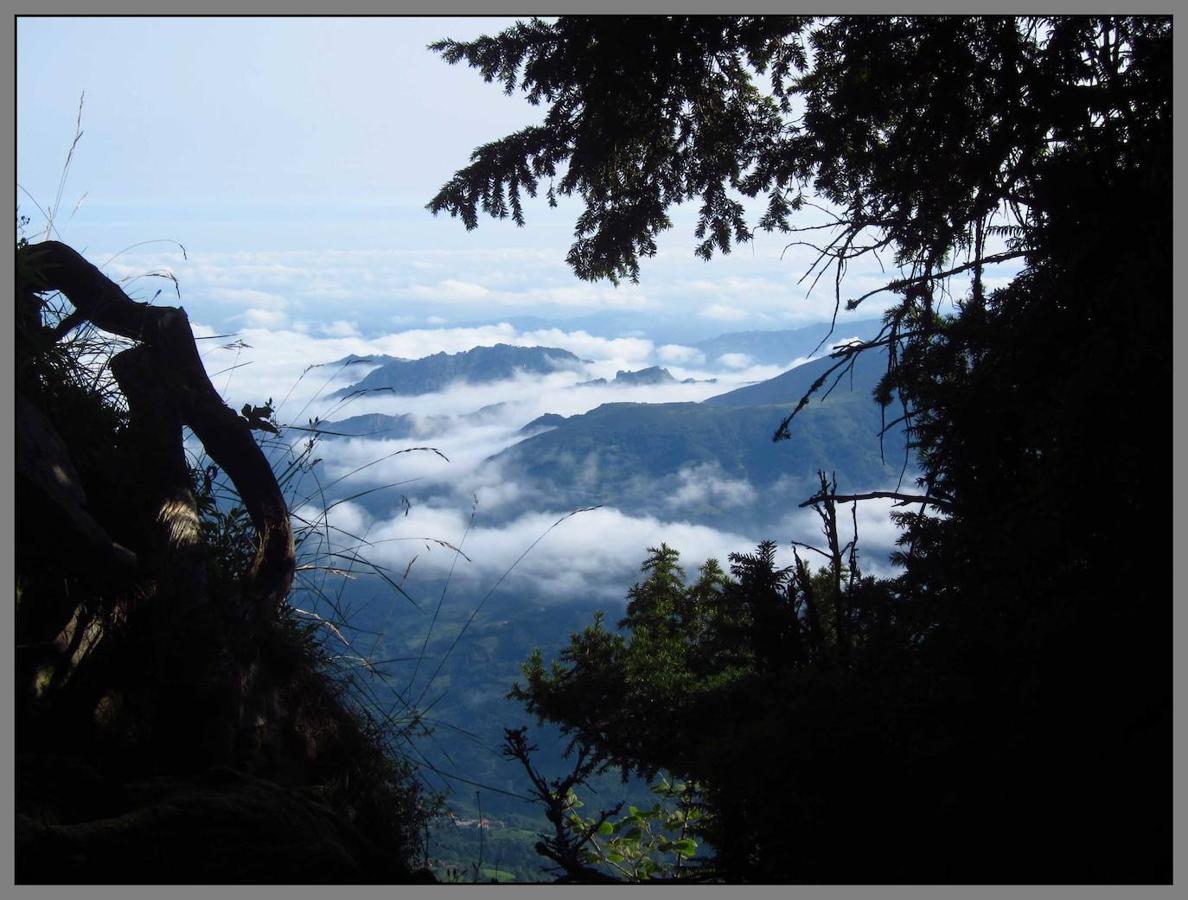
[488,344,903,530]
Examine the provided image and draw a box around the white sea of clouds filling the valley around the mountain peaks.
[187,323,897,602]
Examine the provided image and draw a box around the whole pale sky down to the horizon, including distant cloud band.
[17,18,1002,351]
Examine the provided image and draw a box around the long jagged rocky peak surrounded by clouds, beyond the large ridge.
[331,344,584,397]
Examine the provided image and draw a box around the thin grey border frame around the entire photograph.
[0,0,1188,900]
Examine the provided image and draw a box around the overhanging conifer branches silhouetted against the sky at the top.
[429,17,1170,288]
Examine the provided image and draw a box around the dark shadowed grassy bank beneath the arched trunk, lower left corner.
[12,245,430,883]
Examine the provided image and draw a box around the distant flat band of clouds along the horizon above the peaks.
[95,239,936,340]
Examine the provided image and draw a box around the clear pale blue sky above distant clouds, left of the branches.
[18,18,539,249]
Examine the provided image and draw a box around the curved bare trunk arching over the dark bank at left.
[17,241,296,620]
